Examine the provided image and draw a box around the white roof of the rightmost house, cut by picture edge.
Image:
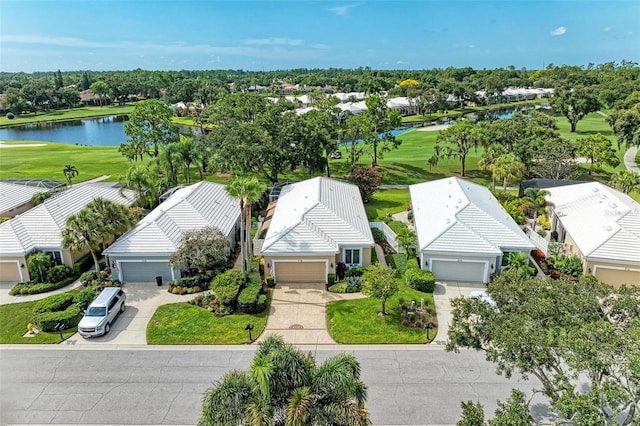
[546,182,640,263]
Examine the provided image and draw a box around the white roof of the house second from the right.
[409,177,535,255]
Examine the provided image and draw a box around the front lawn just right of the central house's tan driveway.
[327,278,437,344]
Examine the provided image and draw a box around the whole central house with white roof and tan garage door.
[259,177,374,283]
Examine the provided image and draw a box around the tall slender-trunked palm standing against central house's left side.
[227,176,266,274]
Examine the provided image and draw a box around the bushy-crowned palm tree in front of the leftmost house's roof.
[62,208,103,272]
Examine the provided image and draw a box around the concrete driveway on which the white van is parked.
[61,283,188,346]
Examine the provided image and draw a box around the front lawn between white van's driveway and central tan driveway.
[147,293,271,345]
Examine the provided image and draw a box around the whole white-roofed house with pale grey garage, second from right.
[409,177,535,283]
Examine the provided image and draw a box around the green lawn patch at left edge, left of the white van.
[0,301,78,344]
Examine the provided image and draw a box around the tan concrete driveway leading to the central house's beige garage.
[257,283,363,345]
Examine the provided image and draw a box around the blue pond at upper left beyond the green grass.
[0,115,199,146]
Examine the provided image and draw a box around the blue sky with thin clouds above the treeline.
[0,0,640,72]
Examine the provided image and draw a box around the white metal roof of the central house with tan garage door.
[262,177,373,254]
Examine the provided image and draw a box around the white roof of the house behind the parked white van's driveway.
[104,182,240,255]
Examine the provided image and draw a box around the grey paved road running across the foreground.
[0,345,544,425]
